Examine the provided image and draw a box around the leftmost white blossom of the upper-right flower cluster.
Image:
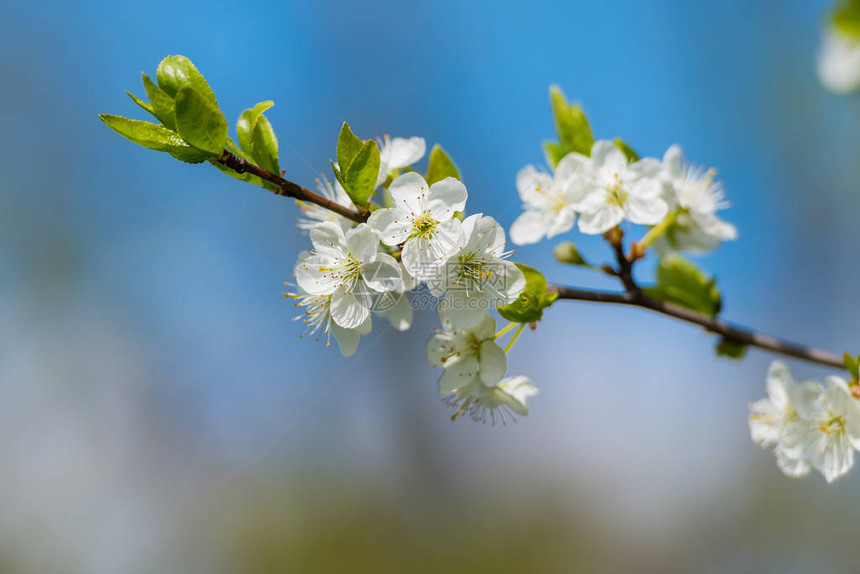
[511,154,591,245]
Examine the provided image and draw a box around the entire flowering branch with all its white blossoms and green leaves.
[101,50,860,482]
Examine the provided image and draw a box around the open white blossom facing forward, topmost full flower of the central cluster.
[367,172,467,281]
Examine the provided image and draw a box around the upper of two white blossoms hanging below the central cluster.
[427,311,508,396]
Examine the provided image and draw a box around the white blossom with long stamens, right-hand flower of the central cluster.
[440,213,526,328]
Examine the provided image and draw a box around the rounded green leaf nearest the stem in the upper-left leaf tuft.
[176,86,229,156]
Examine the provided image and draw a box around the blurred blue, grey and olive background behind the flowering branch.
[0,0,860,574]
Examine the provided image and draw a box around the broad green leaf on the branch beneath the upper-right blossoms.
[643,255,722,317]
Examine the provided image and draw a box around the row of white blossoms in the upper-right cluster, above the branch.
[511,140,737,251]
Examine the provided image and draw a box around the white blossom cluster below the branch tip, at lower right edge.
[749,361,860,482]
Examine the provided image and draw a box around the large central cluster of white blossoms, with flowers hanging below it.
[288,134,537,423]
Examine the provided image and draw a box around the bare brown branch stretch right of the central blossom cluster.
[547,285,844,369]
